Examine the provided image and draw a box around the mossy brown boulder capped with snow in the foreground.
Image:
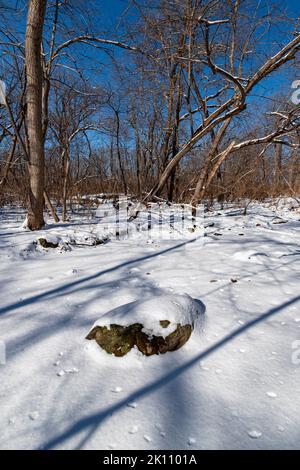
[86,294,205,356]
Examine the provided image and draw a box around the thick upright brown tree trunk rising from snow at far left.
[25,0,47,230]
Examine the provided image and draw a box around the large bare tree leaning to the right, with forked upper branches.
[141,2,300,200]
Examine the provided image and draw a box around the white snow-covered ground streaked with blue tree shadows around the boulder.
[0,201,300,449]
